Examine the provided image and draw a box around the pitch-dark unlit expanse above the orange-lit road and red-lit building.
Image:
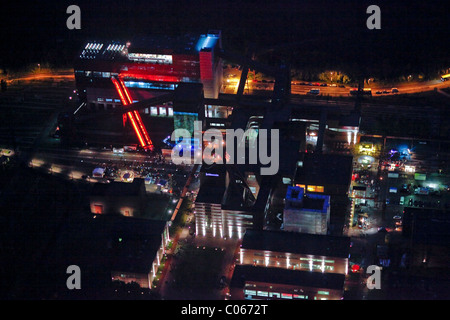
[0,0,450,77]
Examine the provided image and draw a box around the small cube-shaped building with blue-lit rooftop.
[283,186,330,234]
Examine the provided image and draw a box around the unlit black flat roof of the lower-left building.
[52,215,166,274]
